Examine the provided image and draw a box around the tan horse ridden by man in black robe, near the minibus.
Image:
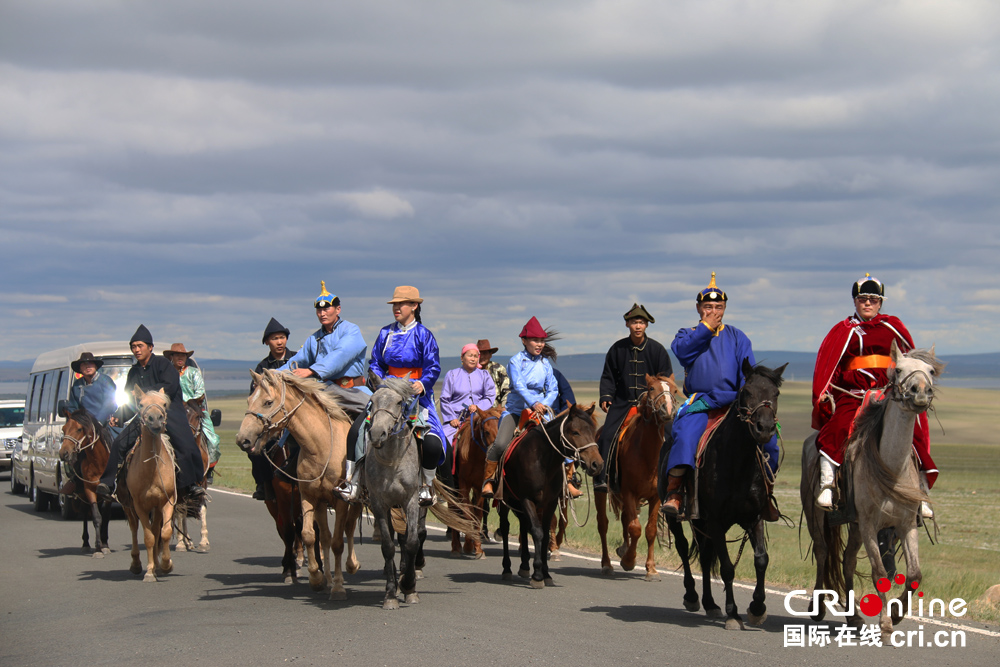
[118,386,177,582]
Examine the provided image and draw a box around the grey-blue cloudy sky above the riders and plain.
[0,0,1000,366]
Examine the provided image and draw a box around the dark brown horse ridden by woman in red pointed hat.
[500,404,604,588]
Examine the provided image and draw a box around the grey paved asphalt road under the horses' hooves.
[0,479,1000,667]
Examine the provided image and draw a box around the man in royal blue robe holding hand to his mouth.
[660,272,779,521]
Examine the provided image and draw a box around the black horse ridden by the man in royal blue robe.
[660,359,788,630]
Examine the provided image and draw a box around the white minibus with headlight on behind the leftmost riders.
[10,341,135,511]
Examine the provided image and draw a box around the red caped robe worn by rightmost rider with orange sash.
[812,315,938,486]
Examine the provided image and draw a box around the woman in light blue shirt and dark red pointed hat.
[483,317,559,498]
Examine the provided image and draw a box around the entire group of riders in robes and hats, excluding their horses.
[76,273,938,521]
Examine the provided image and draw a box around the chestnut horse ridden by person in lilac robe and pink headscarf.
[451,406,503,558]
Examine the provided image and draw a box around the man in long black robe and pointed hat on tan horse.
[97,324,205,501]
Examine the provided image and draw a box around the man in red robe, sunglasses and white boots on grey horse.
[812,274,938,518]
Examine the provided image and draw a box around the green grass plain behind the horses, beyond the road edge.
[212,382,1000,622]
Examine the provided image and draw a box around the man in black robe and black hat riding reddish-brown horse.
[594,303,674,492]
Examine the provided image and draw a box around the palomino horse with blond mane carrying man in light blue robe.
[236,369,361,600]
